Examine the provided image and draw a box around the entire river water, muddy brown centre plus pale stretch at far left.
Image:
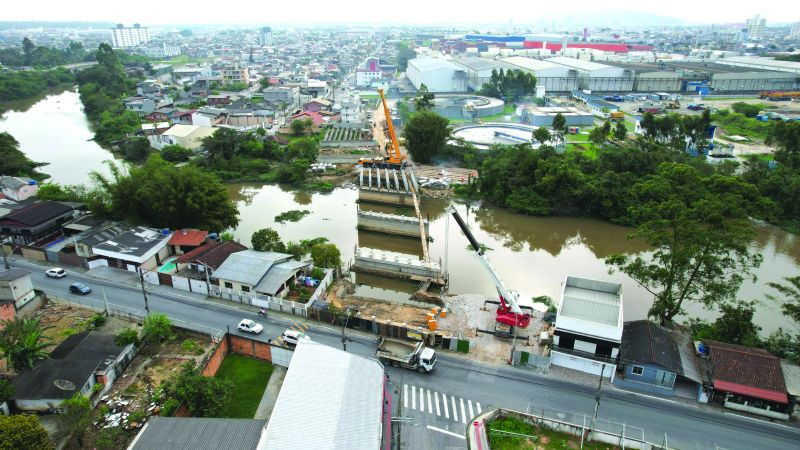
[0,91,800,333]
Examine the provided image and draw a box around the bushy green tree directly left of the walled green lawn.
[162,361,234,417]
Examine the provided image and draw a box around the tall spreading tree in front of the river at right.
[606,163,771,324]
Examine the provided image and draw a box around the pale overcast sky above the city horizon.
[0,0,800,25]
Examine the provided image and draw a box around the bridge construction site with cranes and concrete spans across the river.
[318,92,551,362]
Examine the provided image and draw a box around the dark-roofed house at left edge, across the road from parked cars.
[0,200,81,245]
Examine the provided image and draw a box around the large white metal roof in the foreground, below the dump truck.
[259,341,383,450]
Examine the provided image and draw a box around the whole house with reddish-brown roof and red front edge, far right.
[703,341,789,420]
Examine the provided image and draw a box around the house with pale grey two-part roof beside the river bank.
[211,250,310,297]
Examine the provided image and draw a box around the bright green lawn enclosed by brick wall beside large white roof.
[215,354,272,419]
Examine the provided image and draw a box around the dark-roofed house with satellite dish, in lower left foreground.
[11,331,136,412]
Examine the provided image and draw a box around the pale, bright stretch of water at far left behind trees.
[0,90,119,184]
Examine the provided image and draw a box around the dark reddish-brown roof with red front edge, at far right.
[704,341,788,404]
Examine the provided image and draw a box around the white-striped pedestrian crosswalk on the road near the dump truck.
[403,384,482,424]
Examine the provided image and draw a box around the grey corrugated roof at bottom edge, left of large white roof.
[128,416,268,450]
